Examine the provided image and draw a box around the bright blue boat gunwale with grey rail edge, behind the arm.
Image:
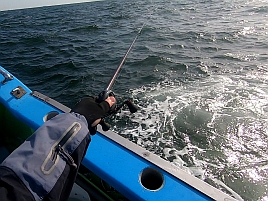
[0,67,237,201]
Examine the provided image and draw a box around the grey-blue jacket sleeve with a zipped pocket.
[0,113,90,201]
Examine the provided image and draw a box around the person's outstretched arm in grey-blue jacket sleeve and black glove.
[0,97,115,201]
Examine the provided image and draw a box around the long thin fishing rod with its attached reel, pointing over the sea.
[97,23,145,131]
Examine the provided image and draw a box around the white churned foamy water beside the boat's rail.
[115,66,268,199]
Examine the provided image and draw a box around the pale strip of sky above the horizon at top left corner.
[0,0,101,11]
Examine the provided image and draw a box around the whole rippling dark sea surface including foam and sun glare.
[0,0,268,201]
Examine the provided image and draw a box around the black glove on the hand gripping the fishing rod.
[71,97,110,135]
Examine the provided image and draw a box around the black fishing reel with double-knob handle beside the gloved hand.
[97,90,138,131]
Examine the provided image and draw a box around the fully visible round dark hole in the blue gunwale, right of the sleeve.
[140,167,164,191]
